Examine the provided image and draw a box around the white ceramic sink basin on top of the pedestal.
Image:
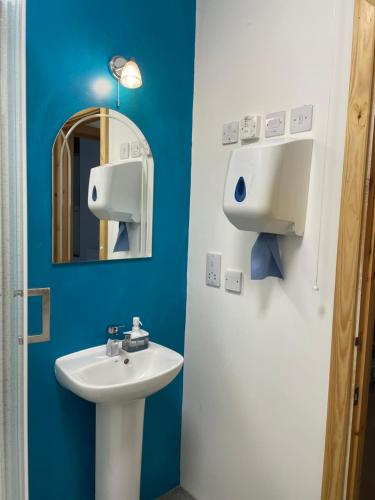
[55,342,183,403]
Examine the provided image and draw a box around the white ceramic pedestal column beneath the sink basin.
[95,399,145,500]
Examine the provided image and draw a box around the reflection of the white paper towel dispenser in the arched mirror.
[88,159,143,223]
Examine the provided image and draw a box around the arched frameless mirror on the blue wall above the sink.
[52,108,154,264]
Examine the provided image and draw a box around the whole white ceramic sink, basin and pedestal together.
[55,342,184,500]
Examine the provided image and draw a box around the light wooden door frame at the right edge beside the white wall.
[321,0,375,500]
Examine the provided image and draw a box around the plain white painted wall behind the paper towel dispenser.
[181,0,353,500]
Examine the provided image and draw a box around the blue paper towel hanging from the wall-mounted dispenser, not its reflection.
[251,233,284,280]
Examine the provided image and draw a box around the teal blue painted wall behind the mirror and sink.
[27,0,195,500]
